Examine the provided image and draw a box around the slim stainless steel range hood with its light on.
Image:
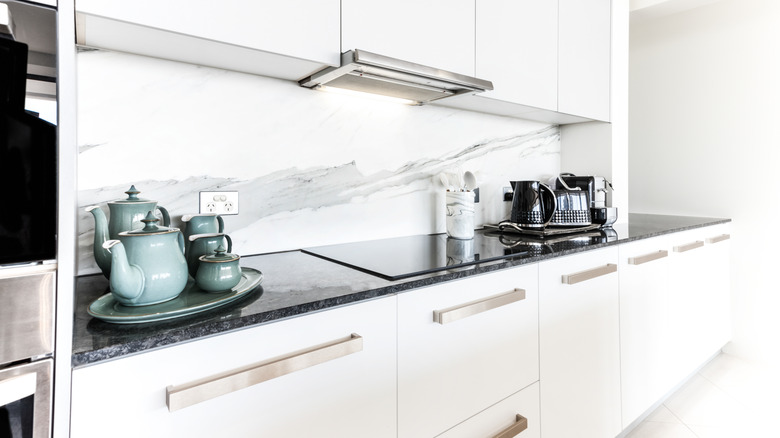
[298,49,493,104]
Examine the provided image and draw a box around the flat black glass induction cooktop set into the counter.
[303,231,528,280]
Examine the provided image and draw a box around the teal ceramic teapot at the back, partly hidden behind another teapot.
[86,185,171,278]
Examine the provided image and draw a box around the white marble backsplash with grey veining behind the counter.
[77,50,560,274]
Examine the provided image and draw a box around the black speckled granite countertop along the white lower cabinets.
[72,214,730,367]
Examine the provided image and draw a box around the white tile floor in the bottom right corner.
[626,354,780,438]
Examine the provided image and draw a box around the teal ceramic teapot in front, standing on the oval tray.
[103,211,188,306]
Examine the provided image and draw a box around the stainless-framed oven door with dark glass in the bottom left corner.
[0,359,53,438]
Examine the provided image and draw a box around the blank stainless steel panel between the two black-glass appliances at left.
[0,265,56,367]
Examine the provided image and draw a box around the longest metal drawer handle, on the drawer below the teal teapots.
[165,333,363,412]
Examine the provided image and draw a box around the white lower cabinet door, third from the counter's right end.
[618,236,679,427]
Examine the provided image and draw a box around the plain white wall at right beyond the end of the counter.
[629,0,780,362]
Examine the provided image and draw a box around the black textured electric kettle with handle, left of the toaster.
[510,181,557,228]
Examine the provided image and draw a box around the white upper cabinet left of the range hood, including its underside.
[75,0,340,80]
